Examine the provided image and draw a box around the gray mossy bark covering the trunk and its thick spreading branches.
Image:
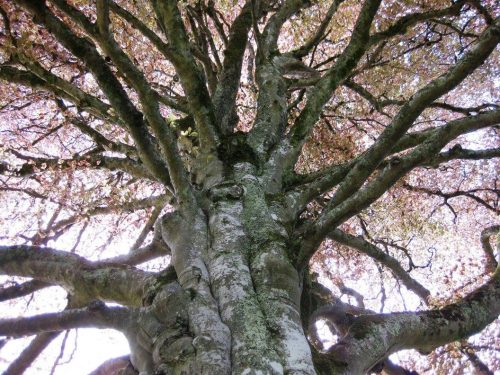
[0,0,500,375]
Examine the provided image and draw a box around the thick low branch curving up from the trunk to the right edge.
[322,269,500,374]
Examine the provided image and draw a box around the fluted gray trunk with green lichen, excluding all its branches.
[128,164,315,374]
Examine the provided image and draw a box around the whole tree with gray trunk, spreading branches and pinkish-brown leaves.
[0,0,500,374]
